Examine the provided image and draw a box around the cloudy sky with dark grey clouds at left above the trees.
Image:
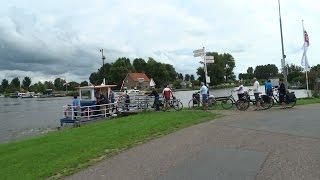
[0,0,320,82]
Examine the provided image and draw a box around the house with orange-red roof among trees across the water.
[124,73,150,90]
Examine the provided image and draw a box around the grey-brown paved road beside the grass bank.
[66,105,320,180]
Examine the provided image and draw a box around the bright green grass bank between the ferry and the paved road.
[0,110,217,179]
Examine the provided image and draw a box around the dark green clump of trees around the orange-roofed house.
[89,57,195,89]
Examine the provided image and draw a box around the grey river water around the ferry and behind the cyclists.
[0,88,307,143]
